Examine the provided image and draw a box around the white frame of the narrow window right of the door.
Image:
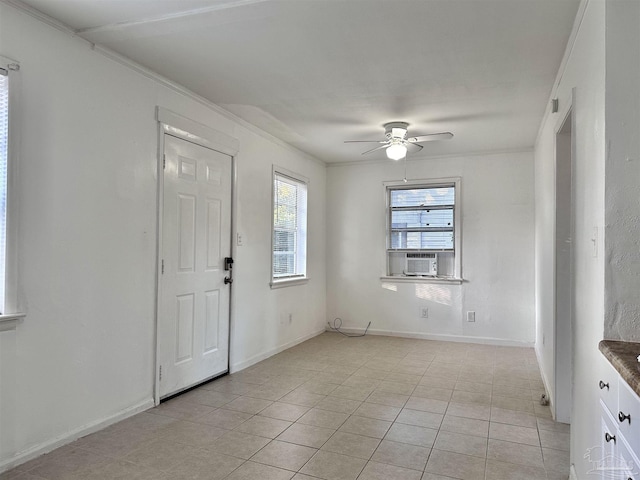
[269,165,309,288]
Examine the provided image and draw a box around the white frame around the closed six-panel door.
[153,106,240,406]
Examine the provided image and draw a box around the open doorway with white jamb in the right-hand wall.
[551,92,576,423]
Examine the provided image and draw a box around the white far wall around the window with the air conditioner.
[327,152,535,344]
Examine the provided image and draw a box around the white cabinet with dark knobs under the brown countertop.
[591,360,640,480]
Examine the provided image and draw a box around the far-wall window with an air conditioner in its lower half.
[386,178,461,279]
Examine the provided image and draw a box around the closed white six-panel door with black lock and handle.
[158,135,232,398]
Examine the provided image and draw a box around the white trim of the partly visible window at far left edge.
[0,56,21,322]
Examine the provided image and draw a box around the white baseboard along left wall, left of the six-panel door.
[0,398,154,473]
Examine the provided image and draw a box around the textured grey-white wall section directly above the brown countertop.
[604,1,640,342]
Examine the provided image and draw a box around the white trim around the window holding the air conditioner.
[380,177,464,285]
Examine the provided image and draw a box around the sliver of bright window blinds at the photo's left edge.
[0,68,9,313]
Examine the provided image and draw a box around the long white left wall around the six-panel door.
[0,3,326,471]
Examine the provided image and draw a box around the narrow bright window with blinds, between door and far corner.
[271,168,308,286]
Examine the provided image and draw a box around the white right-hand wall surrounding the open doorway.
[535,1,605,478]
